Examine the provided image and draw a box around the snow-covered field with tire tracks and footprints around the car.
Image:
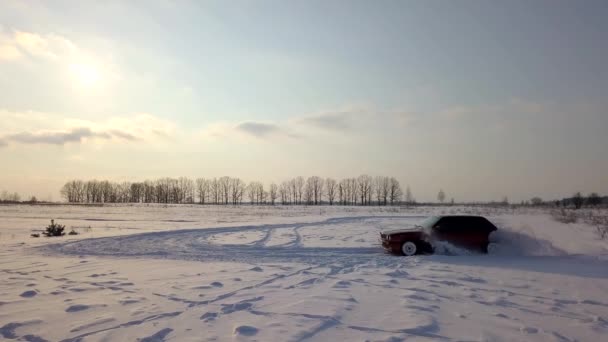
[0,206,608,342]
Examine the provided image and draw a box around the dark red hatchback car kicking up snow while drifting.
[380,215,497,256]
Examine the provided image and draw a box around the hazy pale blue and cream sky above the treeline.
[0,0,608,201]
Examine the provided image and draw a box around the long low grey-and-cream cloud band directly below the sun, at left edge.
[0,111,175,147]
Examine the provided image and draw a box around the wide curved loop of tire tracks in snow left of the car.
[37,216,416,264]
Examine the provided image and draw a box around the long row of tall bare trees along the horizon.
[61,175,411,205]
